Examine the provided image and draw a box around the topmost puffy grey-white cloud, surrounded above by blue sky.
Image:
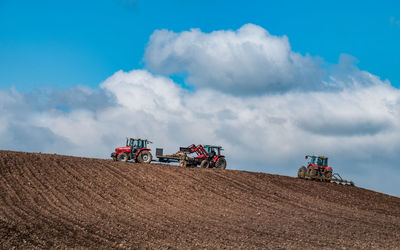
[144,24,324,95]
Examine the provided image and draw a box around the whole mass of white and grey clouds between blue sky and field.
[0,25,400,195]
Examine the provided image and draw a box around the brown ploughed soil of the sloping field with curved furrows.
[0,151,400,249]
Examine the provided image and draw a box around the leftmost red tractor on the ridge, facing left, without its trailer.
[111,138,153,163]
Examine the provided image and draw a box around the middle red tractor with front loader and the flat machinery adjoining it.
[156,144,226,169]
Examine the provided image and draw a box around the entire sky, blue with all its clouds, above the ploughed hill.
[0,0,400,196]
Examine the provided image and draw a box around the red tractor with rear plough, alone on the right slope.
[297,155,354,186]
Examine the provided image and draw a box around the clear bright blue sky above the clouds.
[0,0,400,90]
